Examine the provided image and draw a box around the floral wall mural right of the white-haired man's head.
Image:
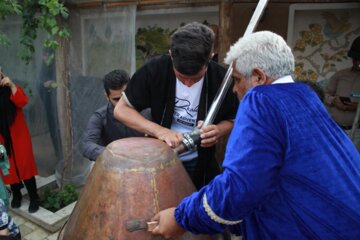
[290,4,360,85]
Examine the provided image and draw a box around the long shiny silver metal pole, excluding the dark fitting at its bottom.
[201,0,268,128]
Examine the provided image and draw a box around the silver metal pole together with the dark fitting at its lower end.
[175,0,268,154]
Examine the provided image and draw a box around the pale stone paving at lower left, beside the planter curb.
[9,212,59,240]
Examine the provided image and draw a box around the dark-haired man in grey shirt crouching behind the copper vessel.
[83,70,150,161]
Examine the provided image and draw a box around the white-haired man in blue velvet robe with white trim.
[152,31,360,239]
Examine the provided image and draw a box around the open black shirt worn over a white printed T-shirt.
[125,55,238,188]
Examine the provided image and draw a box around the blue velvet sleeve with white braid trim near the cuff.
[175,91,285,234]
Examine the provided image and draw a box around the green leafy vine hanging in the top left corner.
[0,0,70,64]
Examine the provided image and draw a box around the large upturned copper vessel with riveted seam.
[60,138,210,240]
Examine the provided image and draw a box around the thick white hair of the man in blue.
[225,31,295,80]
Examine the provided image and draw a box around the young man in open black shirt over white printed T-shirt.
[114,22,238,188]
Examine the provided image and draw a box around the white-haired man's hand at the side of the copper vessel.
[151,208,185,239]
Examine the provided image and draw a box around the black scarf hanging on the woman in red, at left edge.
[0,87,16,155]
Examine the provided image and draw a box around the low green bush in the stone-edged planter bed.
[40,183,79,212]
